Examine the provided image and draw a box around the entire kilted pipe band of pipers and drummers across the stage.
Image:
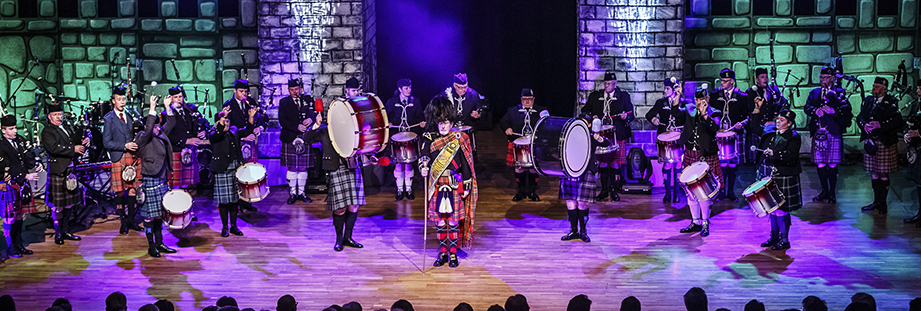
[0,67,921,267]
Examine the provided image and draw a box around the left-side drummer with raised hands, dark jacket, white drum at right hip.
[208,107,257,238]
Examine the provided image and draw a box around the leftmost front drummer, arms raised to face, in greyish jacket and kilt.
[137,96,176,257]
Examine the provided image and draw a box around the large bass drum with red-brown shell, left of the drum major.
[327,94,390,158]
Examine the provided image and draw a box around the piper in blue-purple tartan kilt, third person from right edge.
[803,67,854,203]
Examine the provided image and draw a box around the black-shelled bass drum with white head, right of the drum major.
[531,117,592,178]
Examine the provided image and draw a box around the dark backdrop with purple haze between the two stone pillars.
[376,0,578,120]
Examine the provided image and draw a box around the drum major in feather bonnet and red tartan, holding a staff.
[419,96,477,268]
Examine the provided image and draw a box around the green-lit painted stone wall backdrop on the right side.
[685,0,919,144]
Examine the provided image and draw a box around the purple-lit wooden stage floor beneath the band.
[0,130,921,310]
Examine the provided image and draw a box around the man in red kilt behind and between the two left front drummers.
[160,85,205,189]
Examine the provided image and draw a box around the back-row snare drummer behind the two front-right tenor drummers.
[710,68,752,202]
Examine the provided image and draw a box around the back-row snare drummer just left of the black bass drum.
[499,89,547,202]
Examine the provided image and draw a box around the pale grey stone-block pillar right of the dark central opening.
[576,0,685,120]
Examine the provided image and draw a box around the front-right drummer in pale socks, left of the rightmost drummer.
[679,83,723,237]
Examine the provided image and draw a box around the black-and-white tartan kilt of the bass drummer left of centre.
[326,165,366,211]
